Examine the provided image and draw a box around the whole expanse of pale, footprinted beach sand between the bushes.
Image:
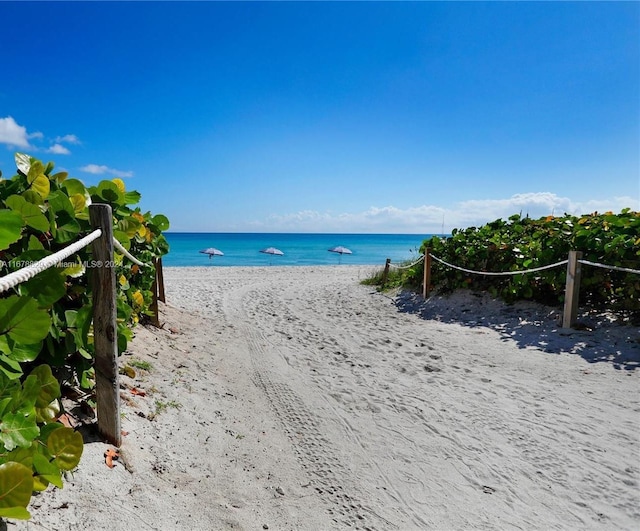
[10,266,640,531]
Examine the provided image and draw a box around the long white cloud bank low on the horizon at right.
[243,192,640,234]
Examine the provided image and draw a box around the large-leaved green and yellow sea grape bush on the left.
[0,153,169,518]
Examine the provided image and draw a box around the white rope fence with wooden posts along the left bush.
[0,204,165,446]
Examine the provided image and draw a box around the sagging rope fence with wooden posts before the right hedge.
[382,249,640,328]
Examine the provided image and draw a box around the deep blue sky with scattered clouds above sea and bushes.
[0,2,640,234]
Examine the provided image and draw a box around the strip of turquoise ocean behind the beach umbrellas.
[162,232,438,267]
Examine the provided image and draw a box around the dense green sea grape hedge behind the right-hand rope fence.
[403,209,640,311]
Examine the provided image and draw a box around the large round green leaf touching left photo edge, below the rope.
[0,295,51,344]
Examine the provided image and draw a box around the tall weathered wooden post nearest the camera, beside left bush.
[89,204,122,446]
